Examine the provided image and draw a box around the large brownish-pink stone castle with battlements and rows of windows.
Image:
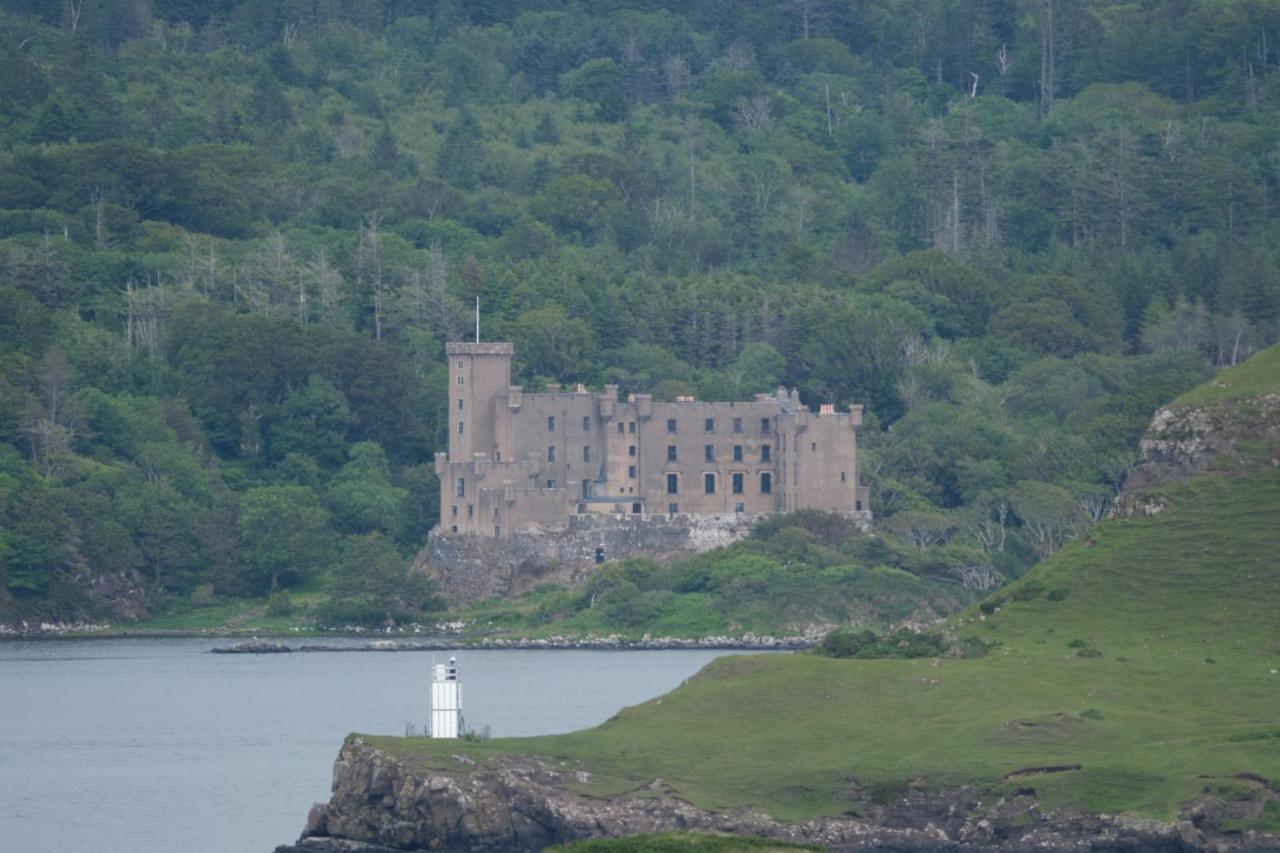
[433,343,870,537]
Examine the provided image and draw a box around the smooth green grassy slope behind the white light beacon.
[363,353,1280,830]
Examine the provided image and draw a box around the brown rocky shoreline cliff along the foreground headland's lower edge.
[275,736,1280,853]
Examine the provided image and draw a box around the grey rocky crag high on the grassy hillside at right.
[1114,394,1280,516]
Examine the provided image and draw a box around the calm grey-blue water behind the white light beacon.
[0,639,747,853]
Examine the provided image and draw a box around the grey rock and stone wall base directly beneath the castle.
[413,514,783,603]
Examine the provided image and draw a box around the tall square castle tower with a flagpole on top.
[444,343,513,462]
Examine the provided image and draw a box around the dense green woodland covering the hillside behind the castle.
[0,0,1280,621]
